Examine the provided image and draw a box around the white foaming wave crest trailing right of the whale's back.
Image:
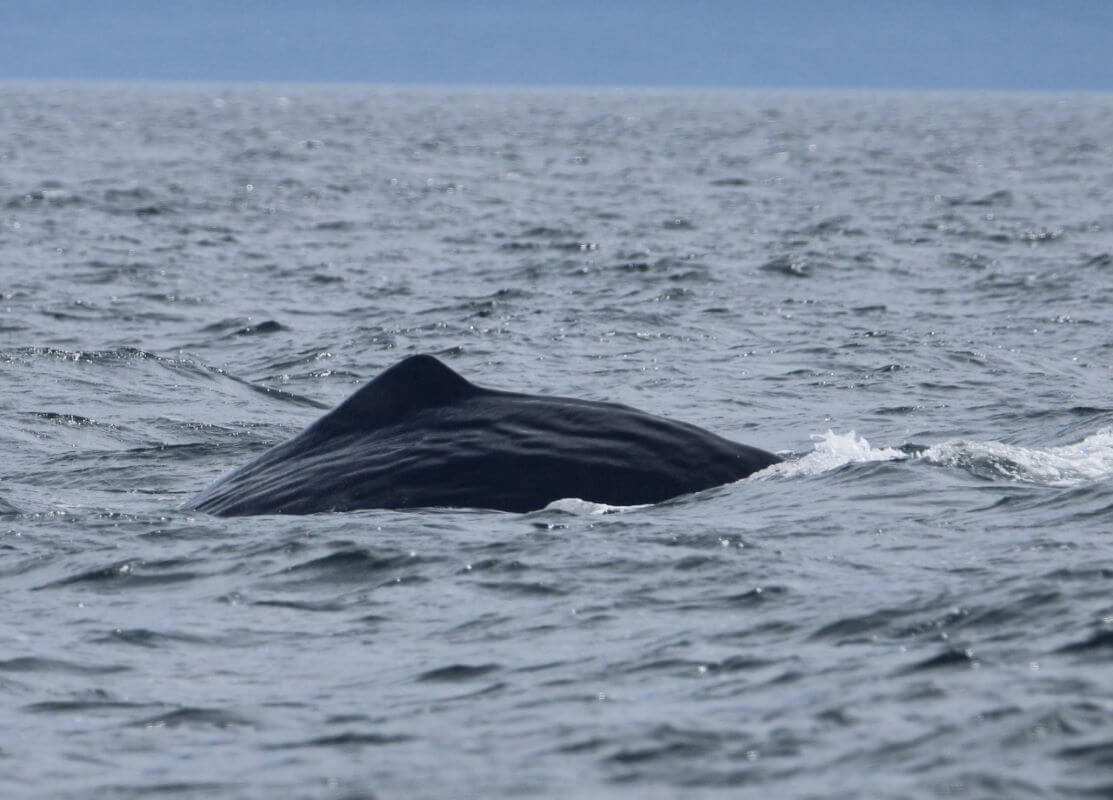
[750,427,1113,486]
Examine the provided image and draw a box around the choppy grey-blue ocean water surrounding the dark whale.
[0,83,1113,800]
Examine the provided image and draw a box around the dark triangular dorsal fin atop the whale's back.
[318,355,480,429]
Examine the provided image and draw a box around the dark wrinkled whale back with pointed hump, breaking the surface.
[183,355,780,516]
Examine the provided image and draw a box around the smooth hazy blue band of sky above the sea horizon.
[0,0,1113,91]
